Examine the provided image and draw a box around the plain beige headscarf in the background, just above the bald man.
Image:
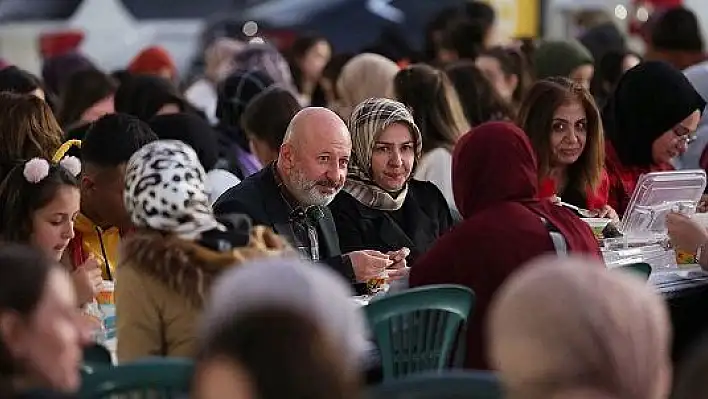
[334,53,399,120]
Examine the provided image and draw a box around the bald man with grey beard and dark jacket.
[214,107,394,283]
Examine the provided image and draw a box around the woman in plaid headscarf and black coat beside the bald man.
[330,98,452,265]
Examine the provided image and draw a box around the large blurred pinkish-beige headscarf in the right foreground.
[487,258,671,399]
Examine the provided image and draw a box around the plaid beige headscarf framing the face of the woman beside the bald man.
[344,98,423,211]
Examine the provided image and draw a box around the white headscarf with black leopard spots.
[123,140,224,240]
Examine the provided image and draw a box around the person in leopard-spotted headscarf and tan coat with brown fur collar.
[115,140,289,362]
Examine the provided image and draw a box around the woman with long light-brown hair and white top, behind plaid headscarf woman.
[393,64,470,210]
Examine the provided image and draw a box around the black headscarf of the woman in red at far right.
[602,61,706,166]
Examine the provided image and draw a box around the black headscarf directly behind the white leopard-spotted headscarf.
[149,113,219,171]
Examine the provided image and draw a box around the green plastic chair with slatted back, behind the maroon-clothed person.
[364,285,475,381]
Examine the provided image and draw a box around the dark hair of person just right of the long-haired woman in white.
[445,61,514,127]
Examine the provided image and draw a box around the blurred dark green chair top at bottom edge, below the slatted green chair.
[366,371,503,399]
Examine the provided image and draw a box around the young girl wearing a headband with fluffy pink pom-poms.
[0,156,102,303]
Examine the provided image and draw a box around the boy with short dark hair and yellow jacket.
[69,114,157,280]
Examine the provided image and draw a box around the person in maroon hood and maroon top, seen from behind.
[410,122,600,370]
